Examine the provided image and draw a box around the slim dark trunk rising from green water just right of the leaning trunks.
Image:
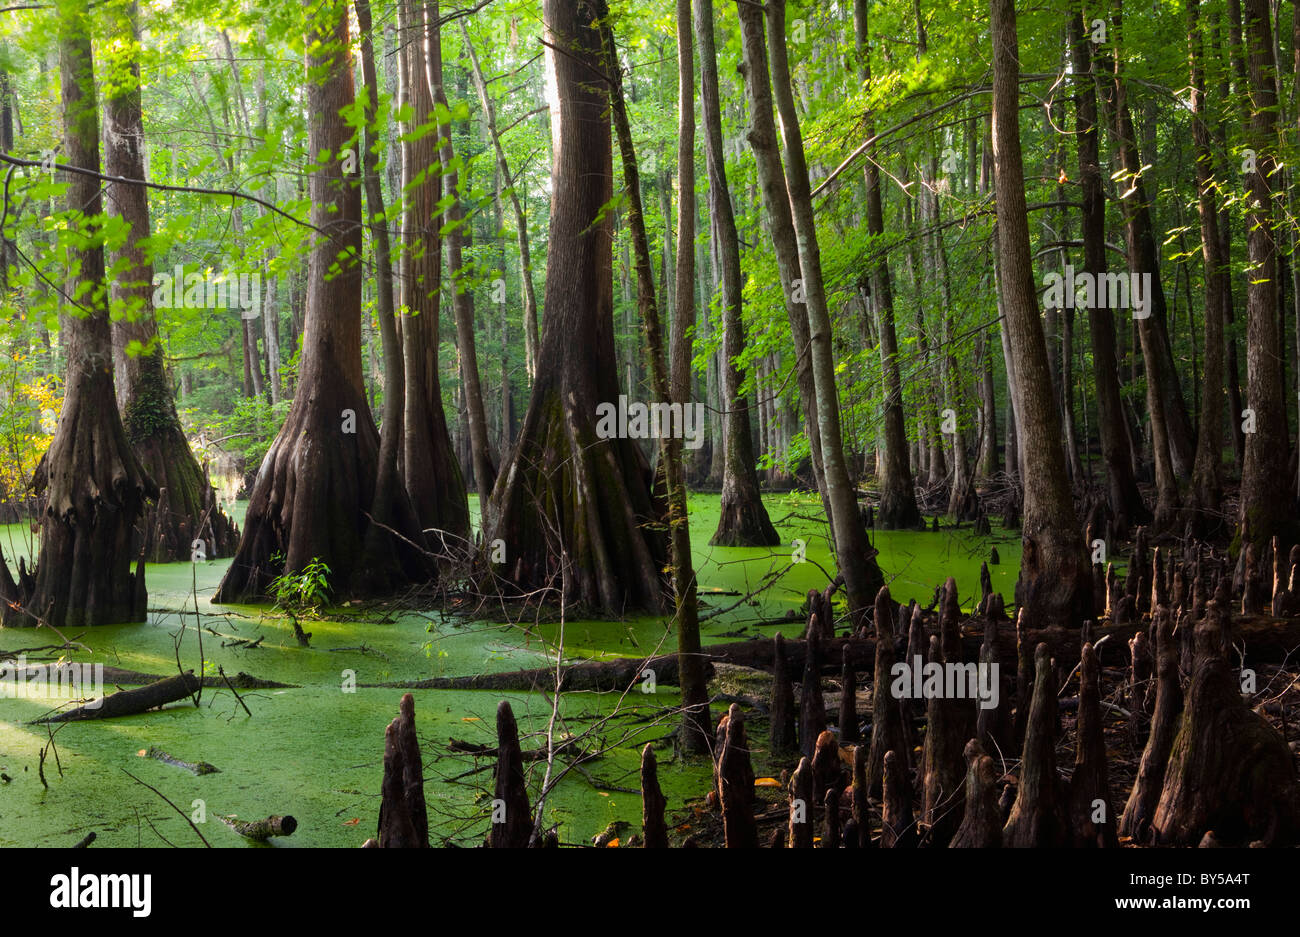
[853,0,922,530]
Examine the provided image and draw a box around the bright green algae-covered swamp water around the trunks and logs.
[0,494,1019,849]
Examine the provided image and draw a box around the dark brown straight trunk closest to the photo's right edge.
[1240,0,1296,548]
